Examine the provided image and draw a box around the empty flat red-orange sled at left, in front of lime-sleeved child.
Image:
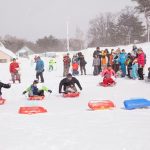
[19,106,47,115]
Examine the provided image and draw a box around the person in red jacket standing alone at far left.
[9,58,21,83]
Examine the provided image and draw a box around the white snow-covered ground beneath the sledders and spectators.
[0,44,150,150]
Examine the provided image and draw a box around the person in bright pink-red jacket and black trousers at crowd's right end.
[137,48,145,80]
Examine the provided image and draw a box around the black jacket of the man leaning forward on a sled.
[59,77,82,93]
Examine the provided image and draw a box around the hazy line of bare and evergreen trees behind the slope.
[0,0,150,53]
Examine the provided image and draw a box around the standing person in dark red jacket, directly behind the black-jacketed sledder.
[63,53,71,77]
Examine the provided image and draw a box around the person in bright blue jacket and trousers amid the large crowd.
[119,49,127,77]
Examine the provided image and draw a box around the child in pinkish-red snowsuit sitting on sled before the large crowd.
[100,65,116,86]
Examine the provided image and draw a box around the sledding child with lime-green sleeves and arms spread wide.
[23,80,52,97]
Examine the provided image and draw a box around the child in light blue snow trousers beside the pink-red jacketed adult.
[131,58,138,80]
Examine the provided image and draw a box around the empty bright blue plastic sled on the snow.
[124,98,150,110]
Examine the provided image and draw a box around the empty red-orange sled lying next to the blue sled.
[88,100,115,110]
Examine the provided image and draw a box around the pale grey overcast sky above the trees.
[0,0,133,41]
